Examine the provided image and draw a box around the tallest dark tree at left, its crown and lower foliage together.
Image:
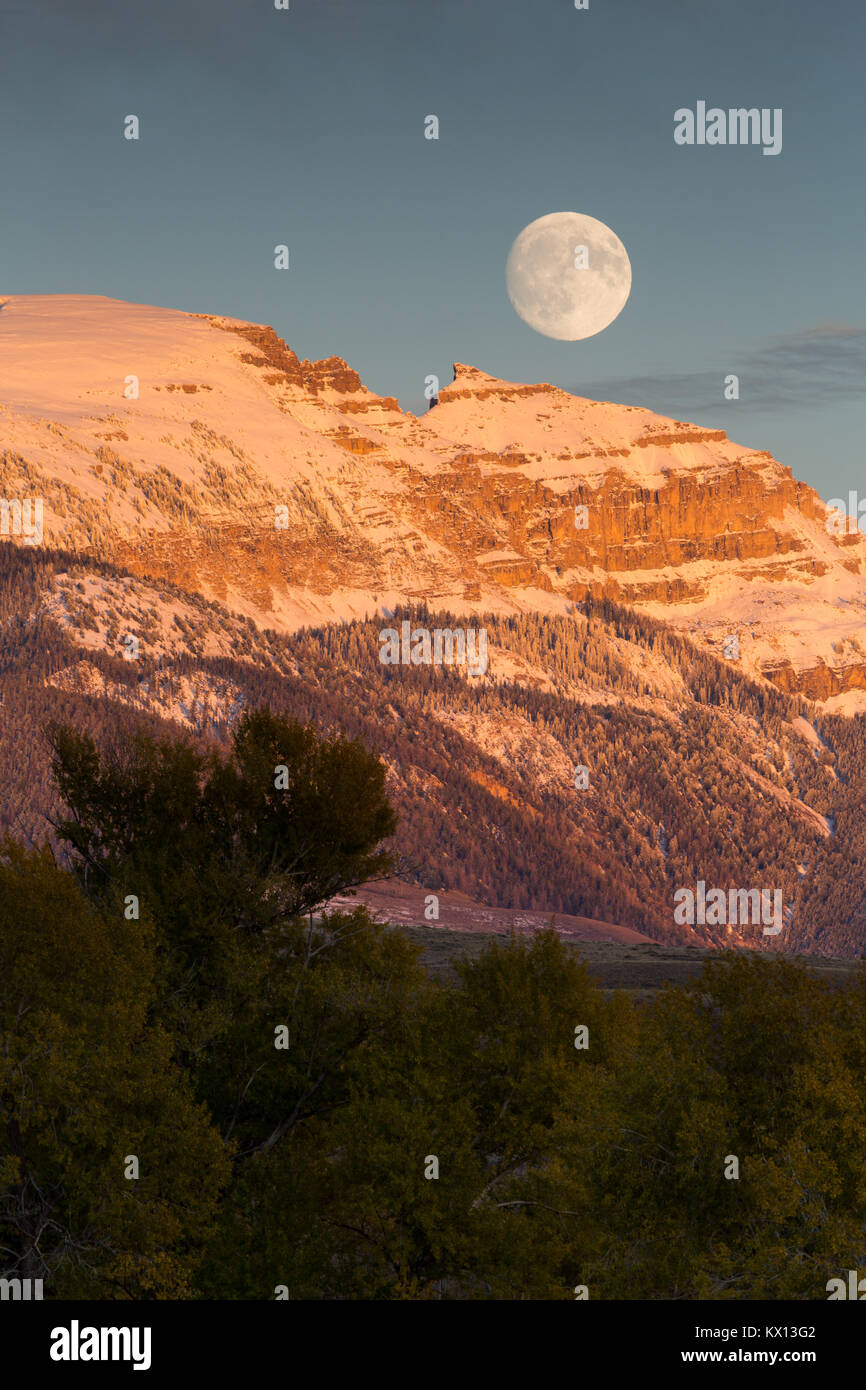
[50,709,418,1178]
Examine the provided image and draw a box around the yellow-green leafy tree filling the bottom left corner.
[0,845,231,1298]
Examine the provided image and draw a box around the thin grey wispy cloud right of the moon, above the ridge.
[583,324,866,416]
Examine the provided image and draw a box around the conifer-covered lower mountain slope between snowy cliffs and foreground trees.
[0,548,866,955]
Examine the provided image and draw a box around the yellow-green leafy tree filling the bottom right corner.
[578,956,866,1298]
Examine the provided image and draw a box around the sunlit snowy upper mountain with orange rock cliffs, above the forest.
[0,295,866,713]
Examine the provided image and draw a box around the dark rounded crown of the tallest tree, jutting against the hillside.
[49,709,396,933]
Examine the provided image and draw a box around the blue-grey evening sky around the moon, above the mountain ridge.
[0,0,866,499]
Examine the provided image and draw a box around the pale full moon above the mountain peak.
[505,213,631,342]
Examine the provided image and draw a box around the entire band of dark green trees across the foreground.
[0,710,866,1300]
